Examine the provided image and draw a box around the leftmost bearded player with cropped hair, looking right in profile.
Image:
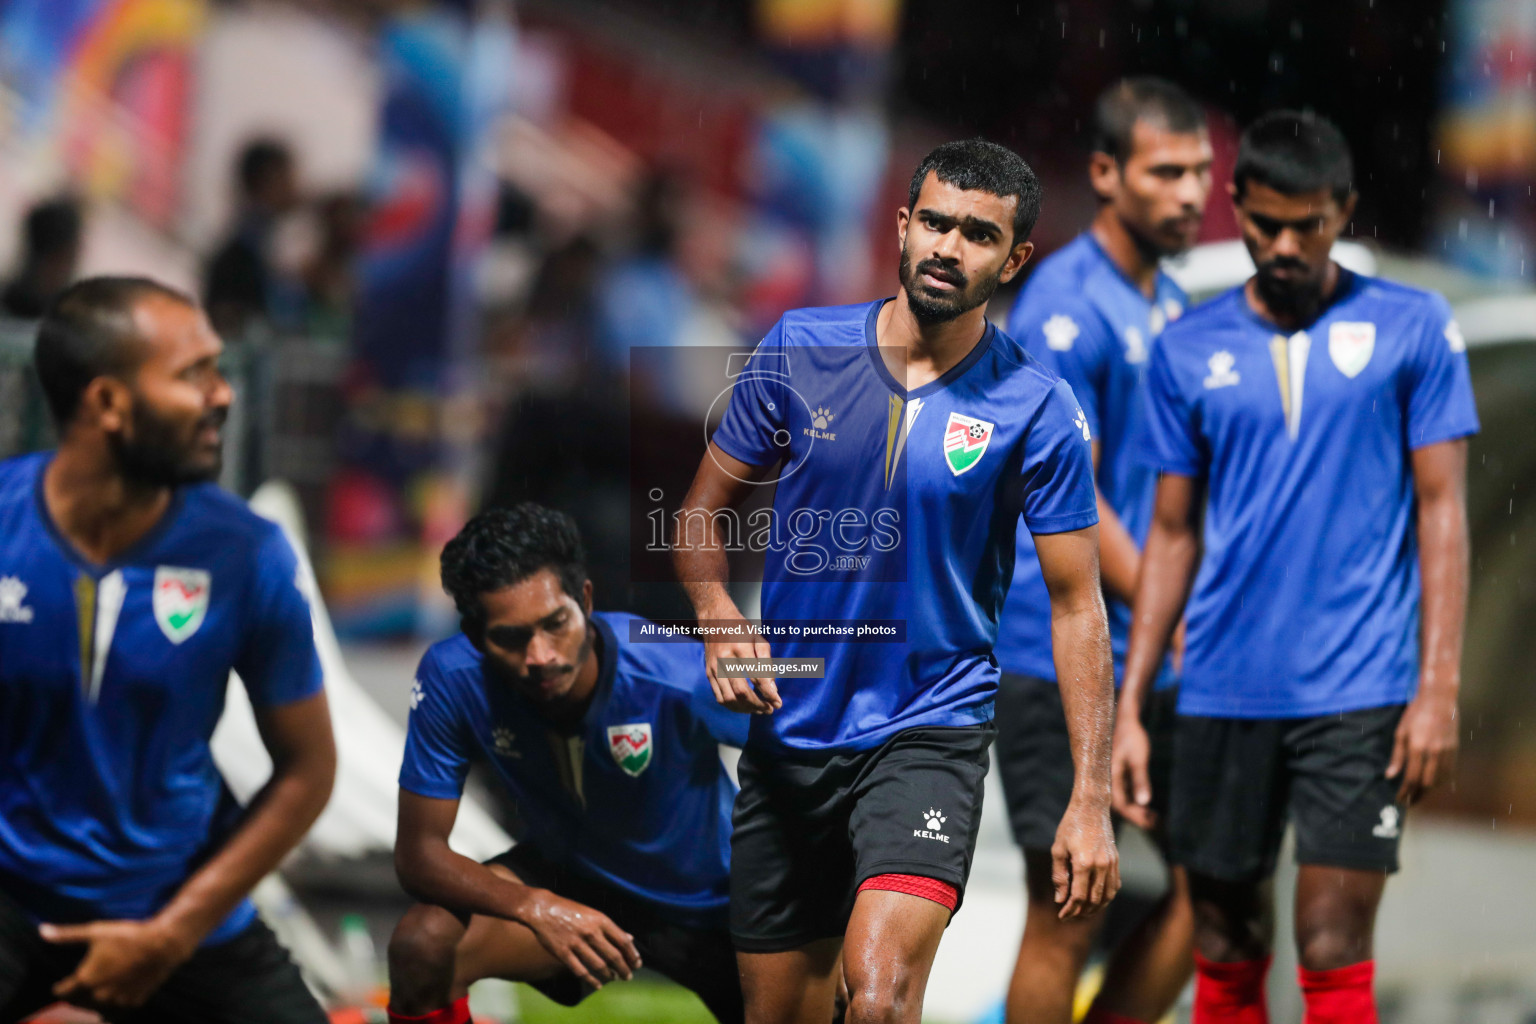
[0,278,335,1024]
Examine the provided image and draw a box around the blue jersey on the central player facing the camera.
[714,299,1098,751]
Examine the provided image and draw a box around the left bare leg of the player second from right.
[1008,849,1103,1024]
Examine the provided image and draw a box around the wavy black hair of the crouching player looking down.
[441,502,587,636]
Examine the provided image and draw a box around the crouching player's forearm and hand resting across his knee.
[395,789,641,987]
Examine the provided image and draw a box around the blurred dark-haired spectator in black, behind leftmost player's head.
[203,138,303,336]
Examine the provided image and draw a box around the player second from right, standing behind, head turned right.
[997,78,1210,1024]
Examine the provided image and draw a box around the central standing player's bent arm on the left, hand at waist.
[673,441,783,714]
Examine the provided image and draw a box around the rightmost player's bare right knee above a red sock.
[1296,864,1387,970]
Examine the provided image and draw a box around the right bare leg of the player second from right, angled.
[1087,867,1195,1021]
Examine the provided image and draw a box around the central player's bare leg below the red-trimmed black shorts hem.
[843,889,949,1024]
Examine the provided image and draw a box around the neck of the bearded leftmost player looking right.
[43,444,170,565]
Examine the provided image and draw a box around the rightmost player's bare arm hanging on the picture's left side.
[1112,473,1200,827]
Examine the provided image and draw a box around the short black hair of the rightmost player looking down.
[1232,111,1355,203]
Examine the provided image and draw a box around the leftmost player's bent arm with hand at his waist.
[43,692,336,1007]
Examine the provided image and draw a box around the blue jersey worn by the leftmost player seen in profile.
[0,453,321,943]
